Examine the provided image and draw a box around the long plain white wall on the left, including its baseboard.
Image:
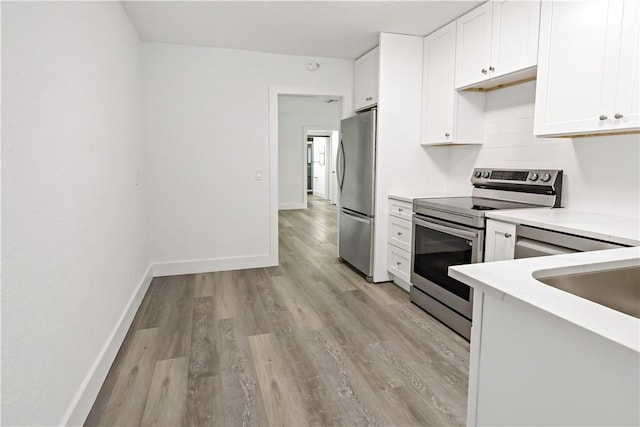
[2,2,148,425]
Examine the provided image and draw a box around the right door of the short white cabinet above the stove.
[489,0,540,78]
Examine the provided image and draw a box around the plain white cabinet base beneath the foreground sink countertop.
[467,285,640,426]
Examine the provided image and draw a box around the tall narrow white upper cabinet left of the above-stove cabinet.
[421,21,484,145]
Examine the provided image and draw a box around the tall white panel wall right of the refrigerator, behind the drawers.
[373,33,447,282]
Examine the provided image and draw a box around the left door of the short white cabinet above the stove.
[455,2,492,89]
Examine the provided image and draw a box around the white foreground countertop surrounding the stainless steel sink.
[449,247,640,352]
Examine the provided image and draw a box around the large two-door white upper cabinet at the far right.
[534,0,640,136]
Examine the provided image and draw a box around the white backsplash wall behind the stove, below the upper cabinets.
[448,81,640,217]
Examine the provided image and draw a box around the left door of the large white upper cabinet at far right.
[534,0,617,135]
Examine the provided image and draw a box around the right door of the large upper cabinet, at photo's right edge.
[610,0,640,131]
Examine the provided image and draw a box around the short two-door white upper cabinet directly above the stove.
[455,0,540,89]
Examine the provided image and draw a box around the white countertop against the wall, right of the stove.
[485,208,640,246]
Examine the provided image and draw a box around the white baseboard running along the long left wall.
[59,265,153,426]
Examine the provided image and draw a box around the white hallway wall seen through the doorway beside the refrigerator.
[278,96,342,209]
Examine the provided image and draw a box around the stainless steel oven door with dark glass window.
[411,215,484,319]
